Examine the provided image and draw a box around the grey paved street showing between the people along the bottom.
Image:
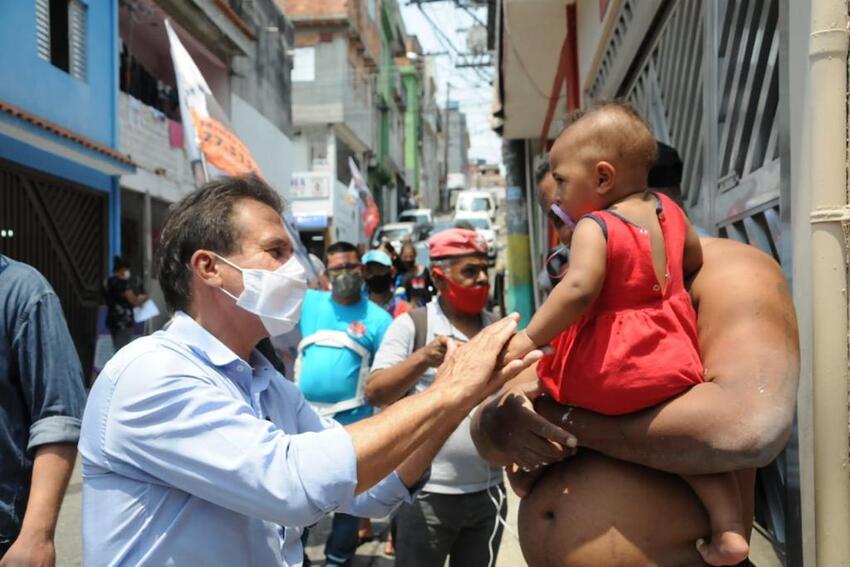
[56,463,525,567]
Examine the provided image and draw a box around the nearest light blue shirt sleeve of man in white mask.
[103,355,357,527]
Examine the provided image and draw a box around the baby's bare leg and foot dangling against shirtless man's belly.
[683,473,750,565]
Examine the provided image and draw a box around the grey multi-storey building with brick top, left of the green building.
[279,0,382,256]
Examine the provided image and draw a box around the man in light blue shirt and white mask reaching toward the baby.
[80,176,541,566]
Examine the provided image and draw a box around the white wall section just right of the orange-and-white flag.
[230,94,295,197]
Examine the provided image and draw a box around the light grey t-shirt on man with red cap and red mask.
[372,299,502,494]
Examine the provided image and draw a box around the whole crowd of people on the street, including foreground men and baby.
[0,103,799,567]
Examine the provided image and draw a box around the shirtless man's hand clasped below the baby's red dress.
[473,372,578,470]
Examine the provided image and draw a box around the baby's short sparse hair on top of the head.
[559,101,658,172]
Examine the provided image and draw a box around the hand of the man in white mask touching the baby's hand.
[435,314,543,410]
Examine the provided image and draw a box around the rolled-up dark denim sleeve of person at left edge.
[12,291,86,451]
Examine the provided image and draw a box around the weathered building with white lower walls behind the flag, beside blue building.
[117,0,293,327]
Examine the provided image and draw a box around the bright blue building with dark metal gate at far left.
[0,0,135,374]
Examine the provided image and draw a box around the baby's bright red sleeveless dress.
[537,195,704,415]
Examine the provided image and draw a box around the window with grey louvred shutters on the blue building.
[35,0,88,81]
